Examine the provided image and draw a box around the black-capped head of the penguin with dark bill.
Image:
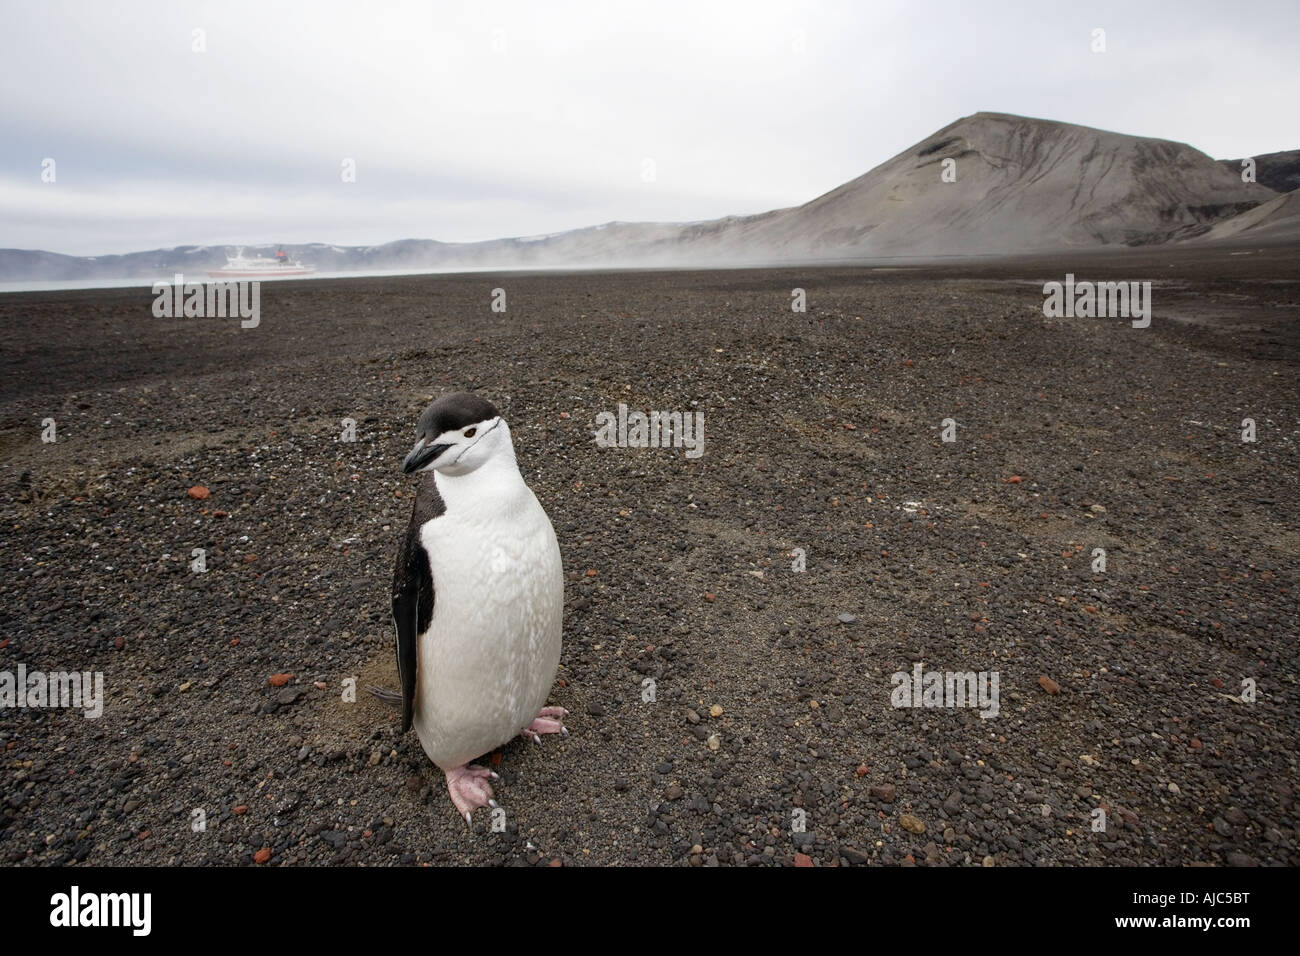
[402,392,514,476]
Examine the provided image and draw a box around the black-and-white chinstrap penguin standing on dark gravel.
[393,392,568,822]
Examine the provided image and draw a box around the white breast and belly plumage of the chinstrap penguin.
[415,480,564,770]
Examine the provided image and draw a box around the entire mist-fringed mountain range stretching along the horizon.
[0,113,1300,281]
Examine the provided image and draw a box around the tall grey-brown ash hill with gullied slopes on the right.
[728,113,1275,258]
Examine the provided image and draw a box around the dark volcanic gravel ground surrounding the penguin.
[0,250,1300,866]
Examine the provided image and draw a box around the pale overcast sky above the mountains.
[0,0,1300,255]
